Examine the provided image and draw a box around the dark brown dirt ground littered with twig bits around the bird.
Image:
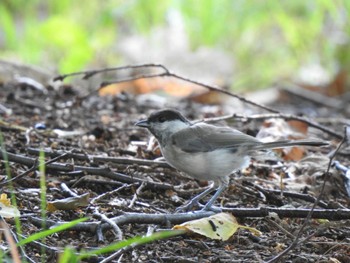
[0,70,350,263]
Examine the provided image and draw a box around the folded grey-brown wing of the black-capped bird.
[172,123,261,153]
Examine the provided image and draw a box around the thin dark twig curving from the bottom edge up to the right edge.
[267,127,347,263]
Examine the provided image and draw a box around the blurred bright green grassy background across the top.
[0,0,350,90]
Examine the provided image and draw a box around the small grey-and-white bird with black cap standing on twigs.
[135,109,327,211]
